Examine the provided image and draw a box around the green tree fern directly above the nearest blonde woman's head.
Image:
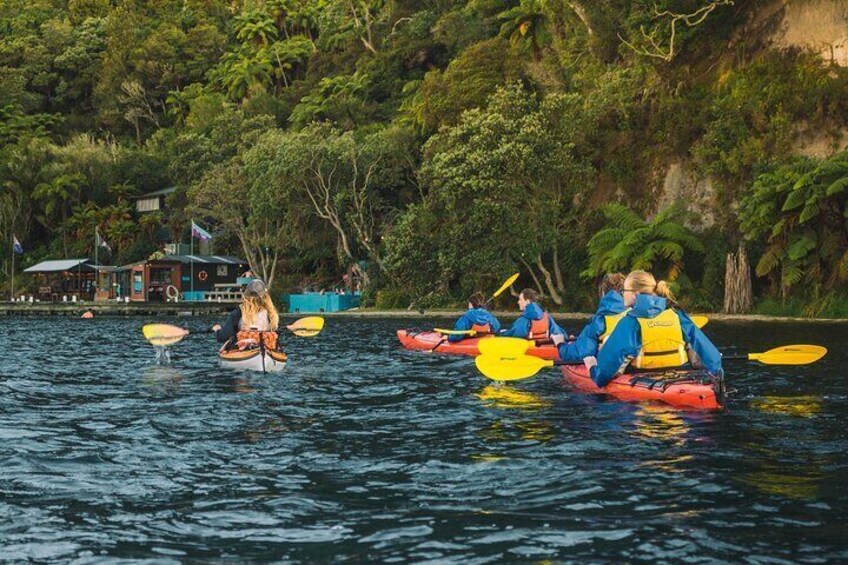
[582,204,704,281]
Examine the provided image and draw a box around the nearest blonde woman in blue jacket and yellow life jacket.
[583,271,723,387]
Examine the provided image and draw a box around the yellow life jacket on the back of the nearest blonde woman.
[632,309,689,369]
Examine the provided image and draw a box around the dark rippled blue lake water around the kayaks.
[0,318,848,564]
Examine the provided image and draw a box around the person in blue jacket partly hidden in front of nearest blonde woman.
[551,273,627,363]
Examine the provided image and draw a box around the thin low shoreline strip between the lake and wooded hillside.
[0,302,848,324]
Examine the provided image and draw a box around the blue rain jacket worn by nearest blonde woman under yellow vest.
[591,294,724,387]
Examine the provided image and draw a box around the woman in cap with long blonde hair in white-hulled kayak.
[212,279,280,350]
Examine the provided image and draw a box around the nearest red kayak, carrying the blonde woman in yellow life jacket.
[562,365,725,410]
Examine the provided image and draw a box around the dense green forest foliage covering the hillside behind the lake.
[0,0,848,312]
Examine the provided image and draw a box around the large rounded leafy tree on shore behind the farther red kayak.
[388,85,594,304]
